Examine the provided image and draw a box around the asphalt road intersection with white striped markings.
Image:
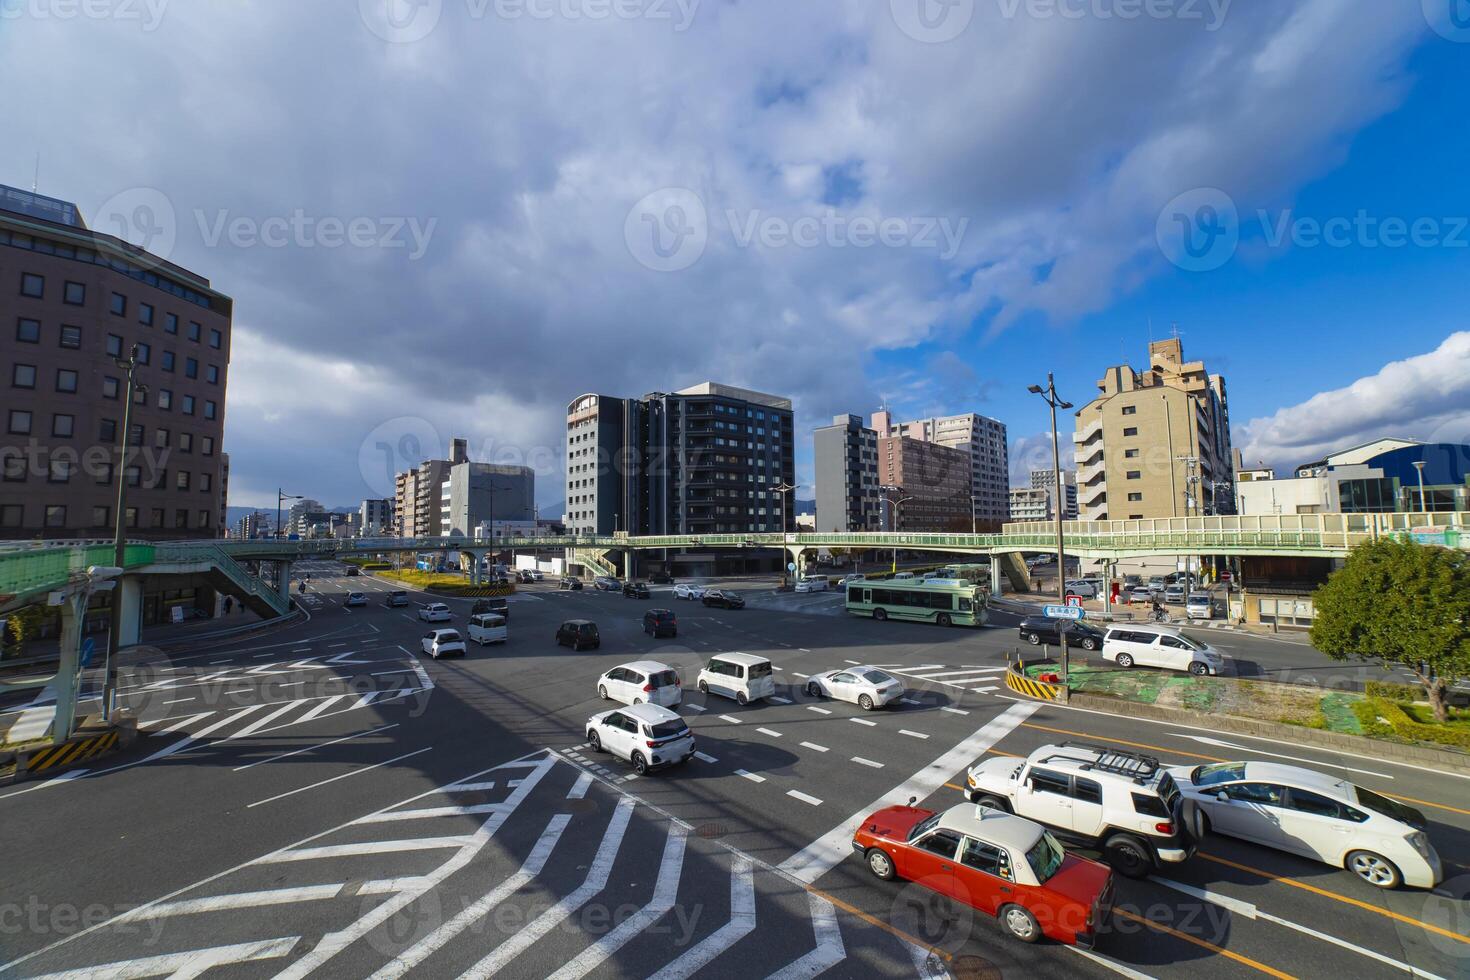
[0,564,1470,979]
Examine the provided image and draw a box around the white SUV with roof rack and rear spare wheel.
[966,742,1197,877]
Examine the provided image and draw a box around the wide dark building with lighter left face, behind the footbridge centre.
[564,382,797,535]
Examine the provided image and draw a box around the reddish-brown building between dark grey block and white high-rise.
[878,435,976,532]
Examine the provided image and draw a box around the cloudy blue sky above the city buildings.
[0,0,1470,505]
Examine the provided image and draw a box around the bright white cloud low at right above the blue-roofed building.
[1236,331,1470,467]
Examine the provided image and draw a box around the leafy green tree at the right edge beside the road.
[1311,541,1470,723]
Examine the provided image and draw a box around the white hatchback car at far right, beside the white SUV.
[1169,763,1444,887]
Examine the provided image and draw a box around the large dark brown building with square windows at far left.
[0,185,234,539]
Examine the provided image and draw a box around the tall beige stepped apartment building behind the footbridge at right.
[1073,338,1235,520]
